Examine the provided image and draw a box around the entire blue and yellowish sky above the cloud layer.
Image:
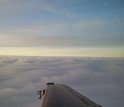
[0,0,124,57]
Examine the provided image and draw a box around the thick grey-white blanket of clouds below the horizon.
[0,56,124,107]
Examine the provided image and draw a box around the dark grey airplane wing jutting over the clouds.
[37,83,102,107]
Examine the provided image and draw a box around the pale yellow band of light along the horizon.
[0,47,124,57]
